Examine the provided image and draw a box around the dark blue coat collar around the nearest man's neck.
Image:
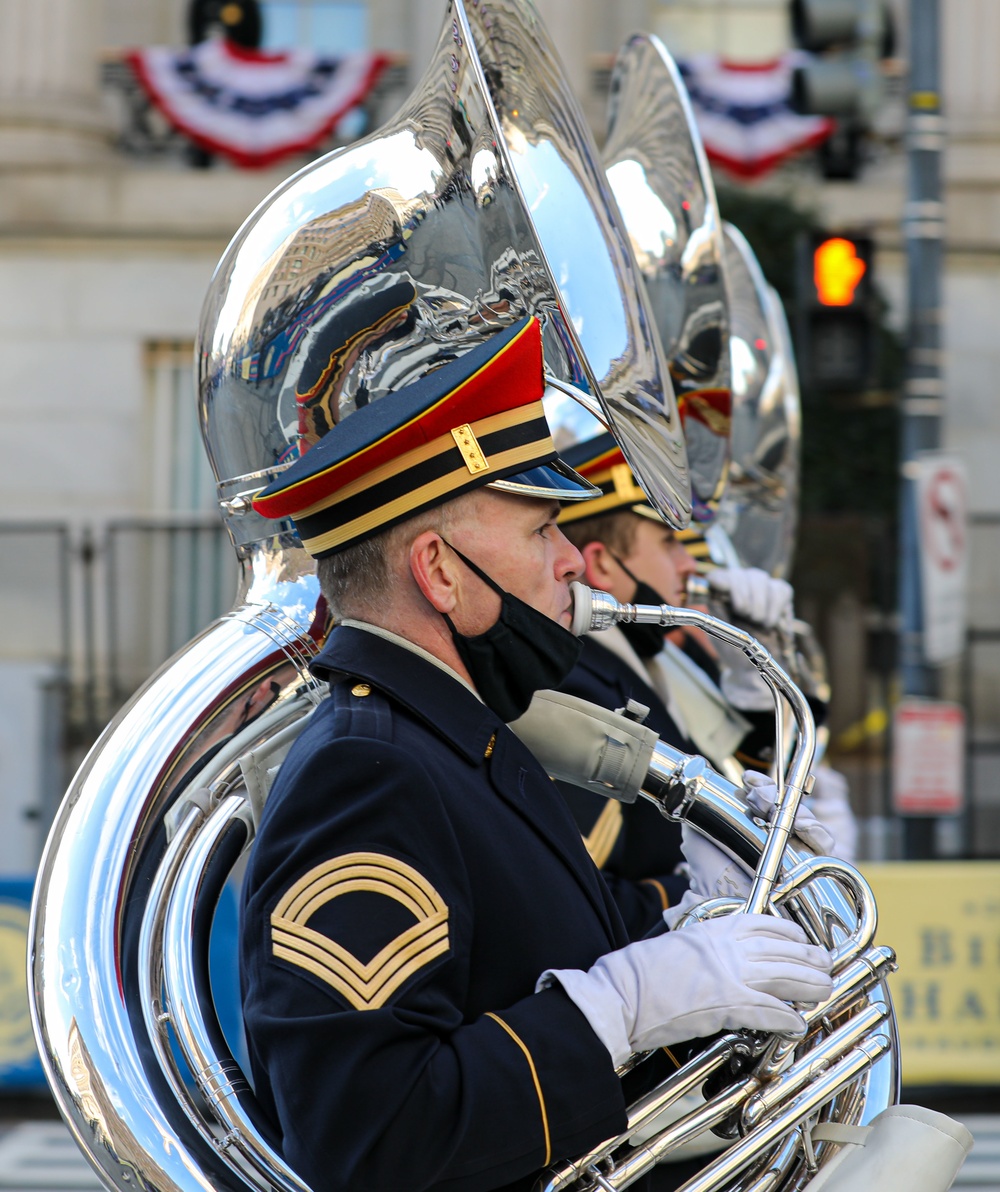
[311,625,503,764]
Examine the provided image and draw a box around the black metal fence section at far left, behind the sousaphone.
[0,517,238,815]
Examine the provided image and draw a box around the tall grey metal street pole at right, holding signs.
[899,0,944,858]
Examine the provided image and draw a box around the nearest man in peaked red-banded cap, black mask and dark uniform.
[241,319,831,1192]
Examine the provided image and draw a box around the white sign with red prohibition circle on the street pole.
[912,452,968,663]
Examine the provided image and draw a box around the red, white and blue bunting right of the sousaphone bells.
[677,51,833,178]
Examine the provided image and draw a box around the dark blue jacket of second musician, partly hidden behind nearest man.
[560,637,697,939]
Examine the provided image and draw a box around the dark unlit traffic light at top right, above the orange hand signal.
[789,0,895,178]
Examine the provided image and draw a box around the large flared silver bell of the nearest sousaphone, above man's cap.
[199,0,690,542]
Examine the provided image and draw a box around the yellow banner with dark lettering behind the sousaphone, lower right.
[859,861,1000,1085]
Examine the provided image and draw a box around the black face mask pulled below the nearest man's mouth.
[442,539,583,724]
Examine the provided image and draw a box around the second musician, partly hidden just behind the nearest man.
[559,434,853,939]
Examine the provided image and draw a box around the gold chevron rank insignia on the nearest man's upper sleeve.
[271,852,451,1010]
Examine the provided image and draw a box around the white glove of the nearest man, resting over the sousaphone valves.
[540,914,833,1067]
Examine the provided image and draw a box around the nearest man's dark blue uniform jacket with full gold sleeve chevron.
[241,626,628,1192]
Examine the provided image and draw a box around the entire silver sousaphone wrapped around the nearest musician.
[30,4,892,1192]
